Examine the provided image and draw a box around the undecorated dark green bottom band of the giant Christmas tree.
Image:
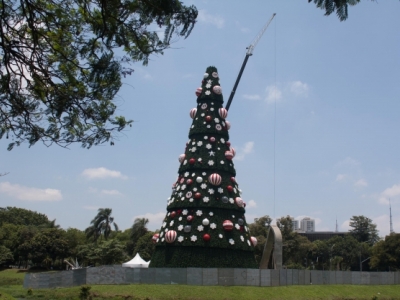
[149,246,258,269]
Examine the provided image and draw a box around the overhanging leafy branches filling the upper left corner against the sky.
[0,0,197,150]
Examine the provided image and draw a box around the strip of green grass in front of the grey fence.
[0,270,400,300]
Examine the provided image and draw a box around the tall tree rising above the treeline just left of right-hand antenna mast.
[349,216,379,246]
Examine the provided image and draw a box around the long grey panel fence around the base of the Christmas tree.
[23,265,400,289]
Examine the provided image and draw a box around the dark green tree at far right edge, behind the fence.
[370,233,400,271]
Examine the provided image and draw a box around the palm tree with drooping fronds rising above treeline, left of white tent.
[85,208,118,241]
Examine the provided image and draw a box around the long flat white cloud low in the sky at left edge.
[0,182,62,202]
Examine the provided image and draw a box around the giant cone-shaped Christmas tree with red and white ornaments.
[150,67,257,268]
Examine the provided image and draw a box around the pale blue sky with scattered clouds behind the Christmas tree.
[0,0,400,236]
